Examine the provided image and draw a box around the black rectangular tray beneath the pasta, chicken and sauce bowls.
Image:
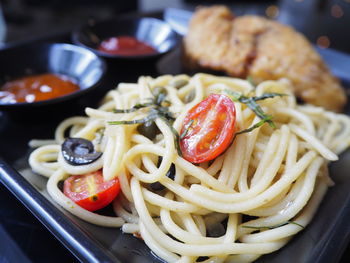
[0,15,350,263]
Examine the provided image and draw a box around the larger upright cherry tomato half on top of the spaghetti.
[180,94,236,163]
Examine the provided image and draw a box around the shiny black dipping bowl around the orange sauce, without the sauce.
[0,43,106,118]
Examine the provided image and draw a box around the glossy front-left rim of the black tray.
[0,158,121,263]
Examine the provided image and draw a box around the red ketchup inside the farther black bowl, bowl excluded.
[97,36,157,56]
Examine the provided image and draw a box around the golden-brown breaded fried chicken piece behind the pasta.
[184,6,346,111]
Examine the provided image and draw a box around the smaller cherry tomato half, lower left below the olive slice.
[63,170,120,211]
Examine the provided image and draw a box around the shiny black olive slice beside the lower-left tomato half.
[62,138,102,165]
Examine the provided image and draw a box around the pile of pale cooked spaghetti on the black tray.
[29,74,350,262]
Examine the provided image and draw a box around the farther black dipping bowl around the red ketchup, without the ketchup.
[72,17,179,60]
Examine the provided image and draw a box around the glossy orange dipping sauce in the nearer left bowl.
[0,73,80,104]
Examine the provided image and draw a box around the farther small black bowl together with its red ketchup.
[72,17,180,60]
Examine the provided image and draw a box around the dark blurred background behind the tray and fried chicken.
[0,0,350,53]
